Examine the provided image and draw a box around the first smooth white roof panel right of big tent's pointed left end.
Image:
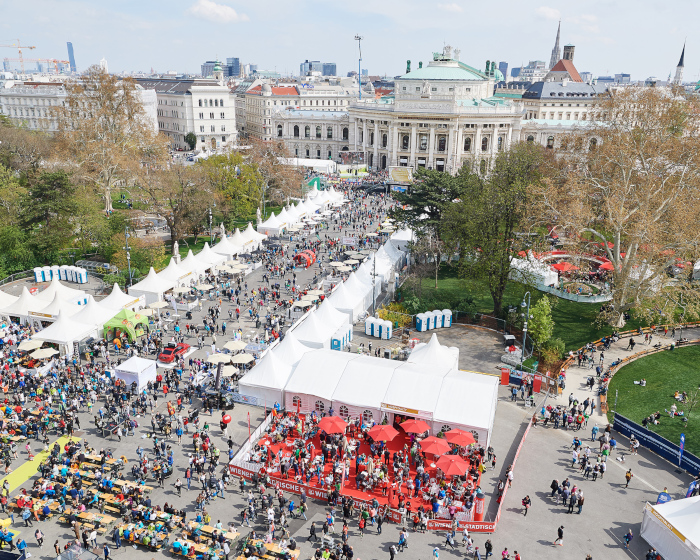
[285,349,359,401]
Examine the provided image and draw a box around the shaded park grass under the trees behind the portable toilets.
[400,266,641,350]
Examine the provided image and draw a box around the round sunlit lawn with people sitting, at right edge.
[608,346,700,455]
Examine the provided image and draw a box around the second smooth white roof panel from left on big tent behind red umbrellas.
[333,356,403,409]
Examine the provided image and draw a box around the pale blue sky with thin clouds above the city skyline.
[0,0,700,81]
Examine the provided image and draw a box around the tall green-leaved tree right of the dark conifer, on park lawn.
[440,142,544,316]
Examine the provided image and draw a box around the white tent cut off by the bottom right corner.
[641,496,700,560]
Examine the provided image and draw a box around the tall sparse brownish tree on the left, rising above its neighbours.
[56,66,167,212]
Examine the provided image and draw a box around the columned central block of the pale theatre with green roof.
[348,47,522,173]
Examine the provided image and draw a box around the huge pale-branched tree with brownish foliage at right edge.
[532,88,700,327]
